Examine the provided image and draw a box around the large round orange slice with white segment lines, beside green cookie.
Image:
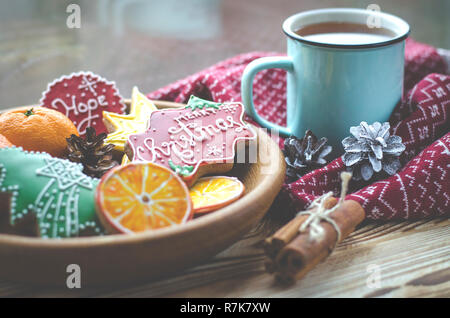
[96,162,192,233]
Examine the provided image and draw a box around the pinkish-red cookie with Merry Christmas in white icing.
[126,97,256,185]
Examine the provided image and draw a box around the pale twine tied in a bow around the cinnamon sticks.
[297,172,352,244]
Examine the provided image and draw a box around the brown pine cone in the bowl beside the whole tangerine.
[66,127,118,178]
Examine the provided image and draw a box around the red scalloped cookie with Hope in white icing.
[40,72,126,136]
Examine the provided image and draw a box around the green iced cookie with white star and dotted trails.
[0,147,103,238]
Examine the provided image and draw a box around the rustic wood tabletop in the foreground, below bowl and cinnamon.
[0,219,450,297]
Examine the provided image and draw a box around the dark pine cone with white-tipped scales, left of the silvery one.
[283,130,332,183]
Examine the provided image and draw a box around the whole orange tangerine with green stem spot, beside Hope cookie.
[0,107,78,157]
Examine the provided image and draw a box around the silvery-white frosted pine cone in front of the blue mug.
[342,121,405,181]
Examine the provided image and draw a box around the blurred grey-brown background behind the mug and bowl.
[0,0,450,109]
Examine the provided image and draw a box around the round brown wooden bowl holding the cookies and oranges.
[0,101,285,288]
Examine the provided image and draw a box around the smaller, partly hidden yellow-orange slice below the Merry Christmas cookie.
[189,177,245,213]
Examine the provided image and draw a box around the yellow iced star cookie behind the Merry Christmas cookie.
[103,87,157,152]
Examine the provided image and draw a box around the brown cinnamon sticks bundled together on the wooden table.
[265,198,365,281]
